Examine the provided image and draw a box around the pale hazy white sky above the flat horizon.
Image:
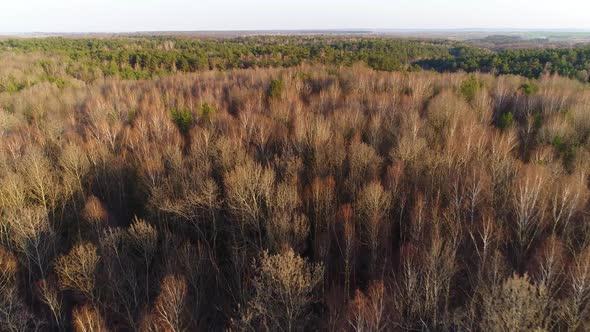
[0,0,590,33]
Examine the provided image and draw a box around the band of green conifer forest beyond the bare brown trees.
[0,36,590,83]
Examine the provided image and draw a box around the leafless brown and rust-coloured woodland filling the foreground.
[0,37,590,331]
